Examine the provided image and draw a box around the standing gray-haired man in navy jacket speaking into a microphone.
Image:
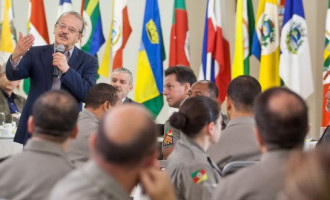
[6,11,98,144]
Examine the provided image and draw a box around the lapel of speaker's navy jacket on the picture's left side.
[40,45,54,88]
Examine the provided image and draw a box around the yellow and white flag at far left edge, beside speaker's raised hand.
[0,0,16,64]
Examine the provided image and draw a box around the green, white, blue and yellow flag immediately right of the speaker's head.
[81,0,105,56]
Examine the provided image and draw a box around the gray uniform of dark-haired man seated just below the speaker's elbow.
[68,109,100,166]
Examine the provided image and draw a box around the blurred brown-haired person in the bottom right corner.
[278,147,330,200]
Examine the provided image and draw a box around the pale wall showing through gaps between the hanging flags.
[0,0,328,137]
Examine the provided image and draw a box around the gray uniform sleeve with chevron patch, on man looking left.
[162,120,181,150]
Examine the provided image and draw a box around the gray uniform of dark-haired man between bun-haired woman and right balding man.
[207,117,261,169]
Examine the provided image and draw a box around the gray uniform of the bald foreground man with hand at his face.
[49,160,131,200]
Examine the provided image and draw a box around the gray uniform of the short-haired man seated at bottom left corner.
[0,139,73,199]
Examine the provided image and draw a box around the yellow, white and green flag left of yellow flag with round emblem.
[232,0,255,79]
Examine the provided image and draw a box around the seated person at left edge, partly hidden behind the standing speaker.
[0,64,26,123]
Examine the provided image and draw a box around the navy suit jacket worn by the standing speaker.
[6,45,98,144]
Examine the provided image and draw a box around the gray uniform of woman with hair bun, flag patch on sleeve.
[167,134,221,200]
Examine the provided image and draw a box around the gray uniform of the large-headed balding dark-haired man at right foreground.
[213,150,290,200]
